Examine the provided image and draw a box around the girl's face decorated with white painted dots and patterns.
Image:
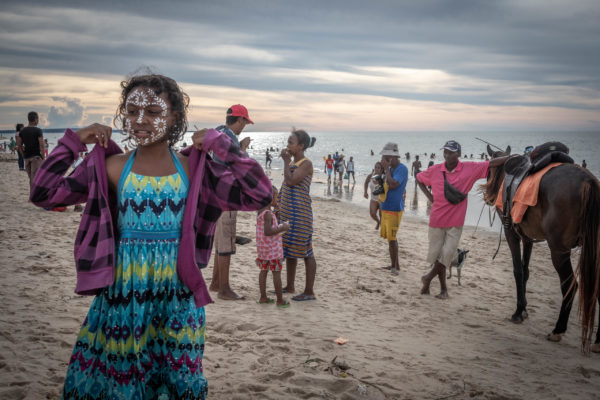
[124,87,168,146]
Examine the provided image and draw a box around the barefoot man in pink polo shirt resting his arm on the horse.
[417,140,505,299]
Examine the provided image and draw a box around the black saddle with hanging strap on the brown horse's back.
[502,142,573,228]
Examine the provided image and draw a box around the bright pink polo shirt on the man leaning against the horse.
[417,161,490,228]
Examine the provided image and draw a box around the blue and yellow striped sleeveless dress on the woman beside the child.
[279,157,313,258]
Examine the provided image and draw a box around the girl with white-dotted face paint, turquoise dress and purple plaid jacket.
[31,75,271,399]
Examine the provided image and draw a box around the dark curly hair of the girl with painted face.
[113,74,190,147]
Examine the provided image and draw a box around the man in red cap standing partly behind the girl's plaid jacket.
[210,104,254,300]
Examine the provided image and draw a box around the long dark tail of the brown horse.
[577,179,600,353]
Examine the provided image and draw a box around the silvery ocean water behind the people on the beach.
[37,131,600,231]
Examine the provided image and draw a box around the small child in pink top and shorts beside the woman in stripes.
[256,186,290,308]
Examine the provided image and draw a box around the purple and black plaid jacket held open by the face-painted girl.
[30,129,272,307]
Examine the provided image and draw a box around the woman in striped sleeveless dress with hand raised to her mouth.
[279,129,317,301]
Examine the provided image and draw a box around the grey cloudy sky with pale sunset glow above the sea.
[0,0,600,131]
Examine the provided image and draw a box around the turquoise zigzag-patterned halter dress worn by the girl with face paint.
[63,151,207,400]
